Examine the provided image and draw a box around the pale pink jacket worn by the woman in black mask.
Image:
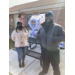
[11,30,29,47]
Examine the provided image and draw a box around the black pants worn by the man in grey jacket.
[42,48,60,75]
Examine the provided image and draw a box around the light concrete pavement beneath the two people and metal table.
[9,46,65,75]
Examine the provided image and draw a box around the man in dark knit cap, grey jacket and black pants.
[38,11,65,75]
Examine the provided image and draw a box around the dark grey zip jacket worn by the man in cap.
[38,22,65,51]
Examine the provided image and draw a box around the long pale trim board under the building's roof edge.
[9,3,65,14]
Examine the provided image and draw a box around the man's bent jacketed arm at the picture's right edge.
[53,27,65,42]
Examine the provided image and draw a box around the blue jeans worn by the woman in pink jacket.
[15,46,27,64]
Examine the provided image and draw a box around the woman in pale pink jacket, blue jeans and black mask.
[11,22,29,68]
